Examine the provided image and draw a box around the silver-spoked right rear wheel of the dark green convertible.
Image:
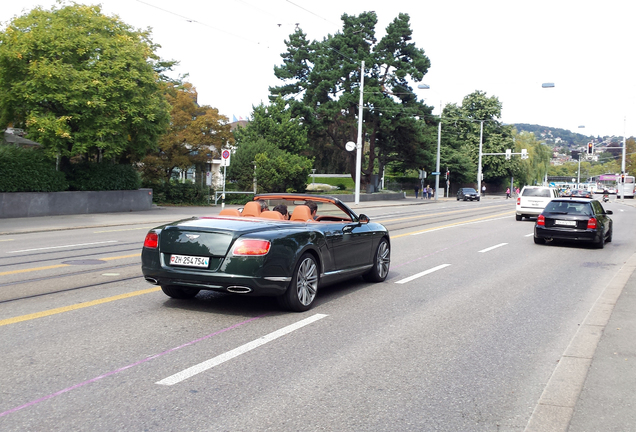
[278,253,319,312]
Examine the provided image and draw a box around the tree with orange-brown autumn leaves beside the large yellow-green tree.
[142,82,234,183]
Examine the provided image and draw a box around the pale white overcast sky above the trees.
[0,0,636,137]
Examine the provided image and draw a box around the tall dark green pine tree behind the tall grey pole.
[270,12,431,183]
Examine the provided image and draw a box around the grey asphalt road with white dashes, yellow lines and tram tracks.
[0,200,636,431]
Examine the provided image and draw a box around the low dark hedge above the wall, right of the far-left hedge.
[66,162,141,191]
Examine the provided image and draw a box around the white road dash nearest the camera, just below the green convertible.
[155,314,327,385]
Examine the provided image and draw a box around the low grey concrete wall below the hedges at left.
[0,189,152,218]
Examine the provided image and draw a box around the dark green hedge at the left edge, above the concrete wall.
[0,145,68,192]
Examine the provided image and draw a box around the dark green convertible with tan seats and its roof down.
[141,194,391,312]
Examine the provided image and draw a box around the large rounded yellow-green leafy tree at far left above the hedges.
[0,4,170,165]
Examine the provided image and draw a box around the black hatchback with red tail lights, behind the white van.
[534,198,614,248]
